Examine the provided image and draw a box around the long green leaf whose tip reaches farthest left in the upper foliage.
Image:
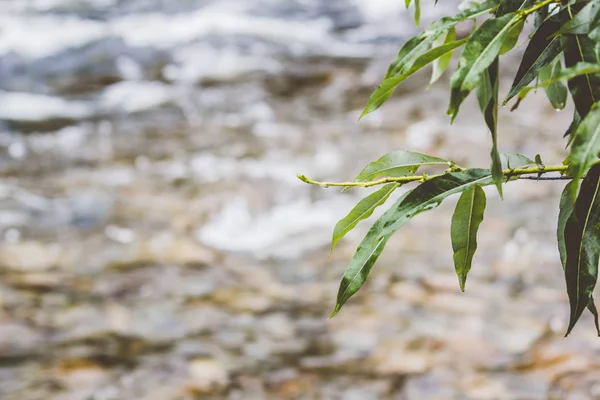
[360,38,468,118]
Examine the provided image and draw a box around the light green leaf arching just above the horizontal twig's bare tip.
[354,151,448,182]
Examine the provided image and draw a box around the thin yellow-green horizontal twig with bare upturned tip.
[298,165,570,188]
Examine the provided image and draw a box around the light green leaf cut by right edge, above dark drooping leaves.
[567,102,600,181]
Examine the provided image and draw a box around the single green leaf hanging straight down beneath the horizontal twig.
[450,186,486,292]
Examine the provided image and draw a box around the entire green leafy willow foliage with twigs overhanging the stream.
[301,0,600,335]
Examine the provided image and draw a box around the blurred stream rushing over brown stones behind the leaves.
[0,0,600,400]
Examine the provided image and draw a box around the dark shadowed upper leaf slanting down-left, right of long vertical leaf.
[504,12,562,104]
